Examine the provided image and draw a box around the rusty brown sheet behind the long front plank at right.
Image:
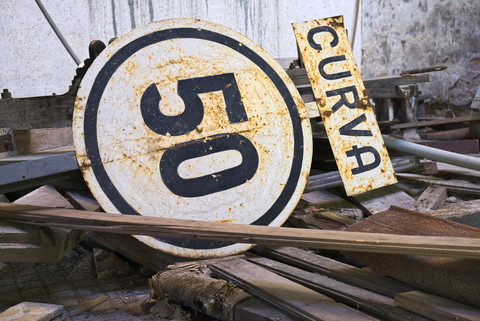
[342,206,480,306]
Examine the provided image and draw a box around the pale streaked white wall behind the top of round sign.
[0,0,361,97]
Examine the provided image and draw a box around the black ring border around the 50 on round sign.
[84,28,304,249]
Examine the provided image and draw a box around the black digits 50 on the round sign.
[140,73,258,197]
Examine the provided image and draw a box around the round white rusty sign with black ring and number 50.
[73,19,312,258]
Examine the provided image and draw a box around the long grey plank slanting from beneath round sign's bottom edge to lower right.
[248,257,427,321]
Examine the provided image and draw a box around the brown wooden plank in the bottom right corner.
[395,291,480,321]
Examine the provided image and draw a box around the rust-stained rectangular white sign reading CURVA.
[293,16,397,195]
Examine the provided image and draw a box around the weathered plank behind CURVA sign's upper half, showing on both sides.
[287,68,430,88]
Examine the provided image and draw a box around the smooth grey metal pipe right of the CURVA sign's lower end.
[383,135,480,171]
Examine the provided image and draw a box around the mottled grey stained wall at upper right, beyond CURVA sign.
[362,0,480,111]
